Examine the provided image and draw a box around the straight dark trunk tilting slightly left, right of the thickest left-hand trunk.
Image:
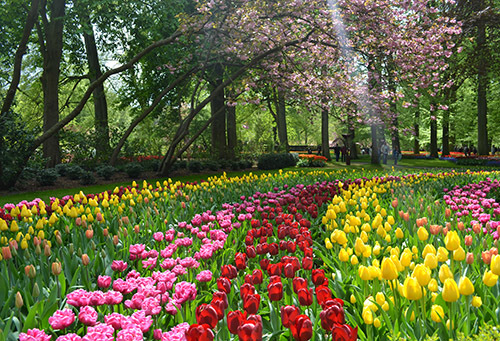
[82,12,111,161]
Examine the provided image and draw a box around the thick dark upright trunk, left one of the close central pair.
[210,64,227,159]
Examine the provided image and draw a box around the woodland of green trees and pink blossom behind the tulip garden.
[0,0,500,187]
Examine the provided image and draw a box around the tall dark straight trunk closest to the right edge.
[477,13,489,155]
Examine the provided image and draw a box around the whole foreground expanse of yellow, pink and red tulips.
[0,170,500,341]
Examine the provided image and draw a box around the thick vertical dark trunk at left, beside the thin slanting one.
[40,0,66,167]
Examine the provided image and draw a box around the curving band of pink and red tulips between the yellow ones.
[12,175,357,341]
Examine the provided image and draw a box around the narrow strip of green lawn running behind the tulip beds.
[0,155,498,207]
